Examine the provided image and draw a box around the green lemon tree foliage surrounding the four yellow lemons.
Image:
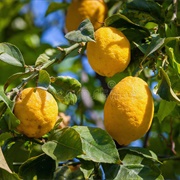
[0,0,180,179]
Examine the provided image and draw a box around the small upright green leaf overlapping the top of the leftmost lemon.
[37,70,51,90]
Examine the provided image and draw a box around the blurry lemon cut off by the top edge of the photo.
[66,0,107,31]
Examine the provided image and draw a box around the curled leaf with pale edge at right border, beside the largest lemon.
[157,68,180,103]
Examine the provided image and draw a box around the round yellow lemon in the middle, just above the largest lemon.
[87,27,131,77]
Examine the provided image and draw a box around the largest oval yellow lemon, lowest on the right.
[104,76,154,145]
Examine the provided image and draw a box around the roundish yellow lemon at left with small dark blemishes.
[14,87,58,138]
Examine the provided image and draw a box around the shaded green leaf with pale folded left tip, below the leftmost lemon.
[42,128,83,161]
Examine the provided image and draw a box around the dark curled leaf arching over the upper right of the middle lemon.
[105,13,150,42]
